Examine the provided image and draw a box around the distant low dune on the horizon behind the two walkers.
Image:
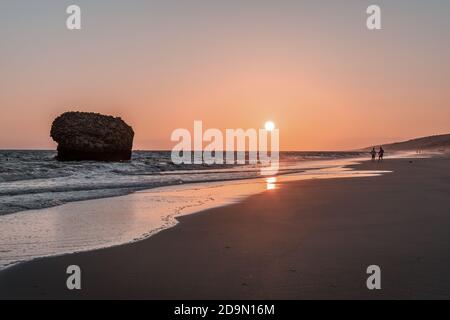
[365,134,450,152]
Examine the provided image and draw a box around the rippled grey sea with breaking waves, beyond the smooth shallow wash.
[0,151,365,215]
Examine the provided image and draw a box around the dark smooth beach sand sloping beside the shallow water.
[0,158,450,299]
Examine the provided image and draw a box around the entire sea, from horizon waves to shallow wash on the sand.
[0,151,370,270]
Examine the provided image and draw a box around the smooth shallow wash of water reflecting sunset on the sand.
[0,160,390,269]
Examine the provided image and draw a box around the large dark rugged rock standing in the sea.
[50,112,134,161]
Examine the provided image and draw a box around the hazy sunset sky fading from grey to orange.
[0,0,450,150]
